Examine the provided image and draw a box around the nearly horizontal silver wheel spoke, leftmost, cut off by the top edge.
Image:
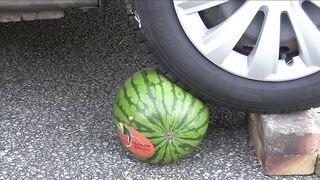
[176,0,228,14]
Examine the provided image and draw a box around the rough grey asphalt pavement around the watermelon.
[0,1,316,180]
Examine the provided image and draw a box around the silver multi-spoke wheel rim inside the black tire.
[173,0,320,81]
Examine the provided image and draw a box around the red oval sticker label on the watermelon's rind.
[118,123,154,158]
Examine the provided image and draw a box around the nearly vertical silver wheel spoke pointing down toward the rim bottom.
[248,9,281,79]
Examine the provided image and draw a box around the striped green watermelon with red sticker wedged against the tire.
[113,69,208,164]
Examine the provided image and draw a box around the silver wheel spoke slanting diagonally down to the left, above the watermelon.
[203,2,260,64]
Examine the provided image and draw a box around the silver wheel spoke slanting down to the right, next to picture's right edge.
[288,4,320,66]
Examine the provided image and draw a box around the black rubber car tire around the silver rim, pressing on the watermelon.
[127,0,320,113]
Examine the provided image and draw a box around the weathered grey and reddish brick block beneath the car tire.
[249,109,320,175]
